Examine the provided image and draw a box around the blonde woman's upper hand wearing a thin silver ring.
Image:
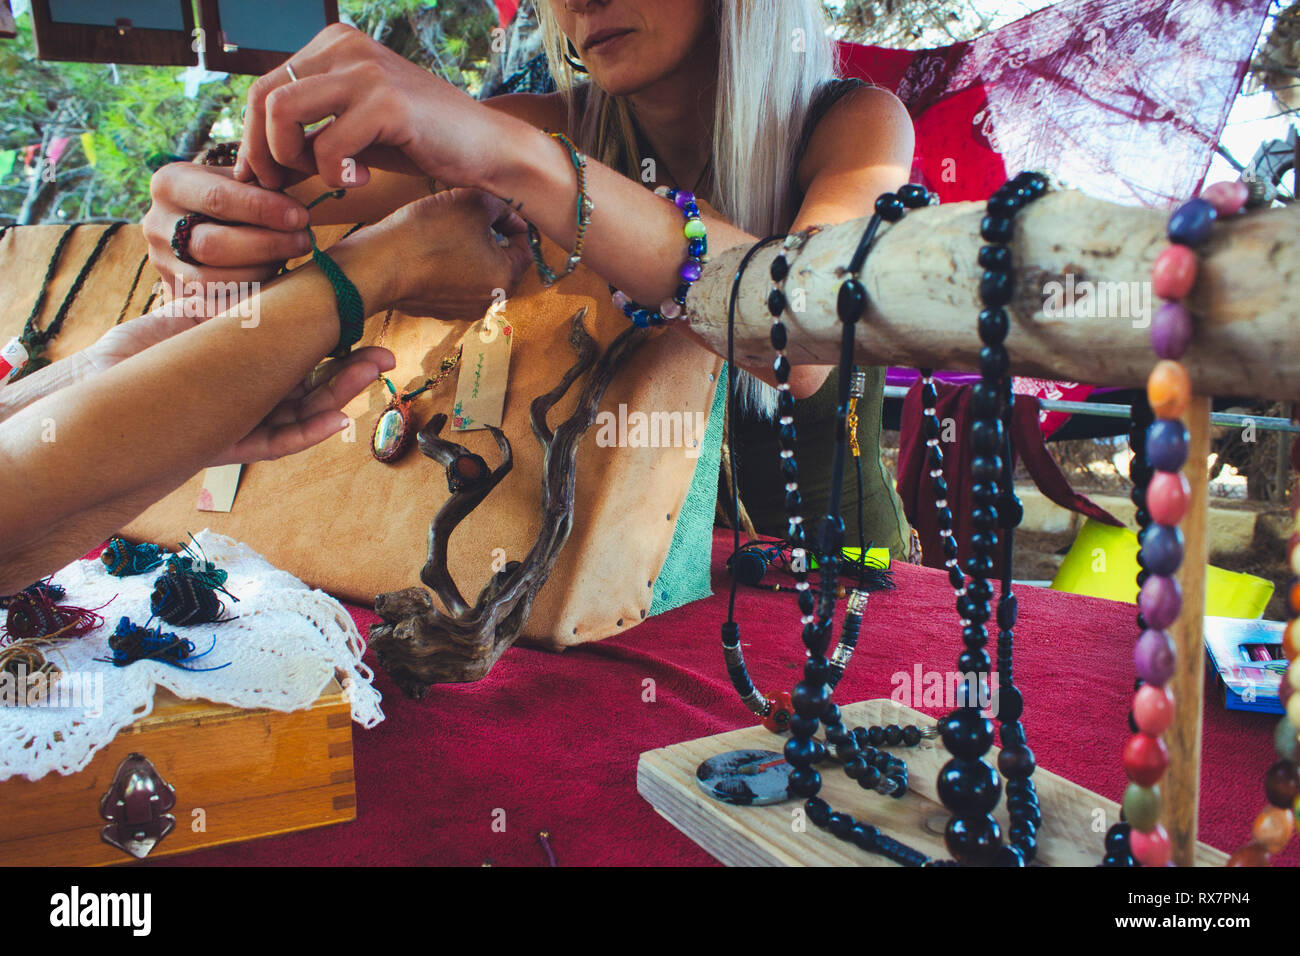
[234,23,514,190]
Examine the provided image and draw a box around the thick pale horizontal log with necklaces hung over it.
[688,191,1300,399]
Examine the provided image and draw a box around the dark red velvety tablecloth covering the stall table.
[153,532,1300,866]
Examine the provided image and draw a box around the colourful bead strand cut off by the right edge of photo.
[1227,488,1300,866]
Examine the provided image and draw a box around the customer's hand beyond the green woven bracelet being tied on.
[358,189,532,321]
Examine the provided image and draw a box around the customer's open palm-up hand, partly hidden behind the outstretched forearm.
[85,299,397,464]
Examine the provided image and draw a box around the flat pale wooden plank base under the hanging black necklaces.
[637,700,1227,866]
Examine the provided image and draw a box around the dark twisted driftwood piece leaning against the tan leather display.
[371,307,646,698]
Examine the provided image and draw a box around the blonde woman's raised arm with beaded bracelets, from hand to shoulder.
[234,25,911,392]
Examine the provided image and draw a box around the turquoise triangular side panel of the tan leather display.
[650,362,727,615]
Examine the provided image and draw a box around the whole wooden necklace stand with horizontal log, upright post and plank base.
[637,191,1300,866]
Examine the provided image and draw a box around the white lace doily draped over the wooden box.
[0,531,384,780]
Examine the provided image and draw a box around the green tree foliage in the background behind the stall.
[0,0,1296,224]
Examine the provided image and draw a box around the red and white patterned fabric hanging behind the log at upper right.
[839,0,1269,436]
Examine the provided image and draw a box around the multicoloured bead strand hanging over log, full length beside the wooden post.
[1123,182,1248,866]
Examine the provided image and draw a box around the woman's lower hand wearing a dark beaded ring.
[140,163,311,286]
